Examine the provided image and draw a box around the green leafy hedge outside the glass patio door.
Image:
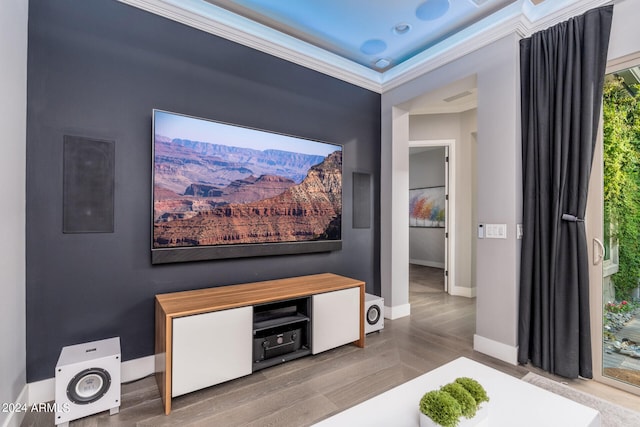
[603,75,640,300]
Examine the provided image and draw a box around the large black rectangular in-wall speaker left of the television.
[62,135,115,233]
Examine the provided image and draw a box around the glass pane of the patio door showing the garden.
[599,66,640,393]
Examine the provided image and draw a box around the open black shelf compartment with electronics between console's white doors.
[253,298,311,371]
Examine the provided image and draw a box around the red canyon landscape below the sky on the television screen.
[153,134,342,248]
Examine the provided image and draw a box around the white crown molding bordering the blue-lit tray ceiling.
[118,0,624,93]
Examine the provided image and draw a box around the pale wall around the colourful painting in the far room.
[409,147,445,268]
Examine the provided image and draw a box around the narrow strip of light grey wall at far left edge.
[0,0,28,425]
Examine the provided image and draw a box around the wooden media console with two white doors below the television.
[155,273,365,414]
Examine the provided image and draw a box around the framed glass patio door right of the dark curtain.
[585,52,640,395]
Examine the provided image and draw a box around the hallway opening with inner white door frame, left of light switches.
[399,83,477,354]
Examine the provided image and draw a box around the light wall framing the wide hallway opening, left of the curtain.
[381,34,521,363]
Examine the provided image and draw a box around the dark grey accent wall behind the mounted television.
[27,0,380,382]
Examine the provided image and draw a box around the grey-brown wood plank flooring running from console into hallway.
[22,266,640,427]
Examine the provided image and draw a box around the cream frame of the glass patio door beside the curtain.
[585,52,640,395]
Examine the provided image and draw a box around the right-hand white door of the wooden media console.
[311,288,360,354]
